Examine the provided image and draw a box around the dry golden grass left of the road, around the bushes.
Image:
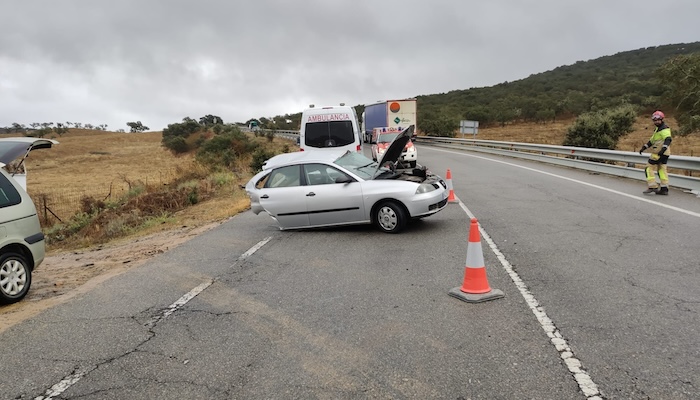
[26,130,260,251]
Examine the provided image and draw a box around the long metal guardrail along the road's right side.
[416,136,700,196]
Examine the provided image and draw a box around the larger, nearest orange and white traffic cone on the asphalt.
[450,218,505,303]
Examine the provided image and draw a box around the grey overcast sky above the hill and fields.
[0,0,700,130]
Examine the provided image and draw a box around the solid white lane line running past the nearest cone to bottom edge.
[455,200,601,400]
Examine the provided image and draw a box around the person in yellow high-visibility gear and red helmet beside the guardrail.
[639,111,671,195]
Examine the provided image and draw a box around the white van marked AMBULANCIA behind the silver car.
[299,103,362,152]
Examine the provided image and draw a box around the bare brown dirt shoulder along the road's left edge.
[0,221,225,332]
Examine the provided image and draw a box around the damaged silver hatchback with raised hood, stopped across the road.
[245,126,448,233]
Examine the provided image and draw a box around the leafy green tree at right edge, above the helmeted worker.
[657,53,700,136]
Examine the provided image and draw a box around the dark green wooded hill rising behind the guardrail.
[259,42,700,134]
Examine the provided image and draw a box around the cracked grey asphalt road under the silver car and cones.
[0,147,700,399]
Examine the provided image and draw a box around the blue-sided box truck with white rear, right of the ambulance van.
[360,99,418,143]
